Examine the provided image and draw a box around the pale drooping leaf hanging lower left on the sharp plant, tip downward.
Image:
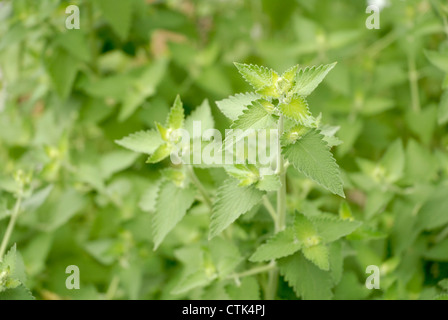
[153,181,196,250]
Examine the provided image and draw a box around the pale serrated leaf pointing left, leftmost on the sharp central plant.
[115,130,163,154]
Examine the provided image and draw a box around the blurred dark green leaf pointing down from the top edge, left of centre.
[96,0,133,40]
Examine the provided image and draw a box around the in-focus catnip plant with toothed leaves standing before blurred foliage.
[117,63,360,299]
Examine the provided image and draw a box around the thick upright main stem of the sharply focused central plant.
[266,115,286,300]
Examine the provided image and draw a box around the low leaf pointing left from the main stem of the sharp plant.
[249,228,302,262]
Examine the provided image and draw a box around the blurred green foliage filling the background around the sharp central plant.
[0,0,448,299]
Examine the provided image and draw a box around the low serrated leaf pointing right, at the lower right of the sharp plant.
[310,217,362,243]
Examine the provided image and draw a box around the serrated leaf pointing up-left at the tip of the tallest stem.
[235,62,278,90]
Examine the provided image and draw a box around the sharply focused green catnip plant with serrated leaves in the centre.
[117,63,360,299]
